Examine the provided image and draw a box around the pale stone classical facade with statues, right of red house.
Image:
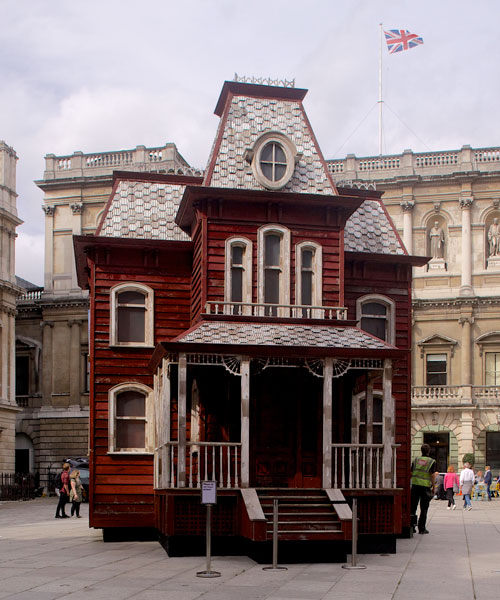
[328,146,500,471]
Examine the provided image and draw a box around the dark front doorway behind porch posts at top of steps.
[250,367,323,488]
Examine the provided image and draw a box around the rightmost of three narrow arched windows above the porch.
[295,242,322,318]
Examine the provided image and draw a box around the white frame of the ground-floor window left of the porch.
[108,382,154,454]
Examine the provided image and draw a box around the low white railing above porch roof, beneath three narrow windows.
[205,302,347,321]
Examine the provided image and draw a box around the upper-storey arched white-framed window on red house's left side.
[110,283,154,346]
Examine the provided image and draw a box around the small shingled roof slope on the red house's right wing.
[344,200,405,255]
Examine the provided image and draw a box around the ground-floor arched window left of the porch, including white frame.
[109,383,154,453]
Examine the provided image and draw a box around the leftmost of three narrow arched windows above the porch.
[225,238,252,315]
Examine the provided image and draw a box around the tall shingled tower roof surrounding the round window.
[205,96,335,194]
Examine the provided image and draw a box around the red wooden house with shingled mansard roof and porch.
[75,82,422,552]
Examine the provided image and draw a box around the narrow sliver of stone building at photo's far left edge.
[0,141,22,473]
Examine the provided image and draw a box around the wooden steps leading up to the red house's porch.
[257,488,344,540]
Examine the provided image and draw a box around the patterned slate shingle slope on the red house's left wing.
[99,181,190,241]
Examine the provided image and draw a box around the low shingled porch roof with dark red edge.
[150,321,407,369]
